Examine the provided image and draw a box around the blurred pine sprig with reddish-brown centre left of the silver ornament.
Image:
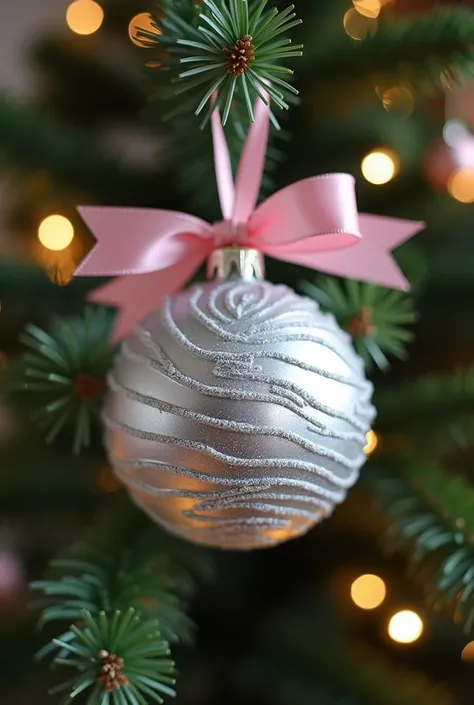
[15,309,115,453]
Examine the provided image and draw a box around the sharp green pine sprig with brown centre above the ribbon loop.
[153,0,302,125]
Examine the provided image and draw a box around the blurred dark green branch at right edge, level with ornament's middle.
[375,369,474,451]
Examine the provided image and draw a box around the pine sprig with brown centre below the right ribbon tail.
[301,277,417,369]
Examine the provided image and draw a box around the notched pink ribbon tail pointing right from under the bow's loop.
[265,215,424,291]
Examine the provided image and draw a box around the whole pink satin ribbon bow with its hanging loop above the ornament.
[76,101,423,338]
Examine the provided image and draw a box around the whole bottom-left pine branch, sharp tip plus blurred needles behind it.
[31,532,200,705]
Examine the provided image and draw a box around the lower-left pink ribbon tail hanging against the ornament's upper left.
[88,255,203,342]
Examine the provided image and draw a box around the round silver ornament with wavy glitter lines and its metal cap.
[104,249,374,549]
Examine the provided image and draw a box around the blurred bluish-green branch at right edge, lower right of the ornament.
[365,460,474,632]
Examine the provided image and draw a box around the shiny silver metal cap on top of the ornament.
[207,246,265,281]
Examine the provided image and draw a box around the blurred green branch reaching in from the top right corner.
[313,7,474,89]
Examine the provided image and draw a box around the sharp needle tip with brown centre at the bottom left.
[51,608,175,705]
